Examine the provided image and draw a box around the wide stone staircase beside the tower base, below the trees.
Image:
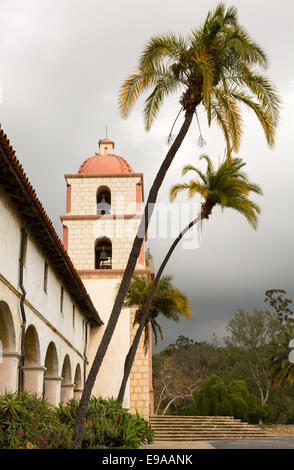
[150,415,278,441]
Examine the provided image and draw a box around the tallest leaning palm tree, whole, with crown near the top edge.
[74,3,279,447]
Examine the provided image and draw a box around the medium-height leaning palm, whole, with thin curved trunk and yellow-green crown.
[117,155,262,401]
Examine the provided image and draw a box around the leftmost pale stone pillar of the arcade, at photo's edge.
[0,352,21,395]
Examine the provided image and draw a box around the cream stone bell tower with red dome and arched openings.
[61,139,151,417]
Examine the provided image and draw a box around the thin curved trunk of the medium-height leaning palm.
[117,215,202,402]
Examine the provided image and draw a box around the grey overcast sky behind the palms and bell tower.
[0,0,294,351]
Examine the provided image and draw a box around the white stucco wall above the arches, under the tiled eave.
[0,187,87,394]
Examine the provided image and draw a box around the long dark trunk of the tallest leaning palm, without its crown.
[74,110,194,448]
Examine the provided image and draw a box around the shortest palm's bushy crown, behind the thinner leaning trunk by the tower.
[124,274,192,351]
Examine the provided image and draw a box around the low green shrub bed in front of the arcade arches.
[0,392,153,449]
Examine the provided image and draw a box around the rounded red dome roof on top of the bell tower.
[78,154,134,175]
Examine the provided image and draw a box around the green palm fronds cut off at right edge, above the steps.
[269,327,294,387]
